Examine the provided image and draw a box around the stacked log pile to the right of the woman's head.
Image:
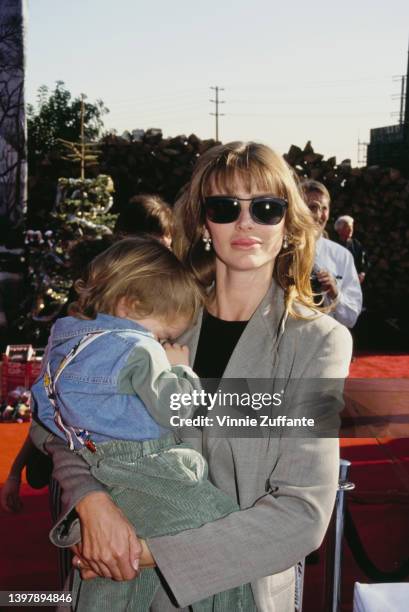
[284,142,409,316]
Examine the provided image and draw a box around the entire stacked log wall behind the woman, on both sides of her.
[30,129,409,316]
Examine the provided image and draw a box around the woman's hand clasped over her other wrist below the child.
[74,491,143,580]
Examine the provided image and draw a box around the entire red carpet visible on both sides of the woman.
[0,355,409,612]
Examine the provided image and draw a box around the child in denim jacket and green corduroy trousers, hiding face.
[32,238,255,612]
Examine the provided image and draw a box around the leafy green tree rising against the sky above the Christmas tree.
[27,81,109,167]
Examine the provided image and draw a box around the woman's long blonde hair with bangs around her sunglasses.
[173,142,316,317]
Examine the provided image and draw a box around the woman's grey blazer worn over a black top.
[32,283,352,612]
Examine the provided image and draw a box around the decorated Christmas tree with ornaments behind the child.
[15,175,117,346]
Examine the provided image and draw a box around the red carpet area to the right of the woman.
[303,355,409,612]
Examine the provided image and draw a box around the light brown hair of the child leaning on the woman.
[69,238,203,322]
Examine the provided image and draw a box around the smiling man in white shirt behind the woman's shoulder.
[301,180,362,328]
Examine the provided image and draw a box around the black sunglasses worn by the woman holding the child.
[203,195,288,225]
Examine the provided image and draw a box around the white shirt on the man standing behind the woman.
[314,237,362,327]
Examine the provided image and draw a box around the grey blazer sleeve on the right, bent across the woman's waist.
[148,324,352,607]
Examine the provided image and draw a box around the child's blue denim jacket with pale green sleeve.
[32,314,200,448]
